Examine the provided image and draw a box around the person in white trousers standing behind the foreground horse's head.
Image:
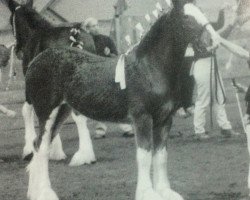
[192,2,241,139]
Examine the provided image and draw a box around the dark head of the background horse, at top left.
[7,0,33,59]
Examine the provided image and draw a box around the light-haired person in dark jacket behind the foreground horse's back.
[84,17,134,139]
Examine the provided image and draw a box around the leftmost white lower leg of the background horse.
[22,102,36,158]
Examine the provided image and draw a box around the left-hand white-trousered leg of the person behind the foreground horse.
[193,58,210,134]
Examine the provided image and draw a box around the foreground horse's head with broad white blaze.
[172,0,220,47]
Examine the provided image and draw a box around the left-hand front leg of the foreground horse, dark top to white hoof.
[133,114,163,200]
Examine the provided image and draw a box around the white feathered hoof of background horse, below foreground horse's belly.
[69,152,96,167]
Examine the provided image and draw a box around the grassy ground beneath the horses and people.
[0,79,248,200]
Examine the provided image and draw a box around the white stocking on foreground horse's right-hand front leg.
[153,148,183,200]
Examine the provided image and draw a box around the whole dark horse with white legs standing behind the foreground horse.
[7,0,96,166]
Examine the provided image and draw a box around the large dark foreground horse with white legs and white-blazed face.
[23,0,219,200]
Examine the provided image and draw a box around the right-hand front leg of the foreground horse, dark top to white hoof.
[153,120,183,200]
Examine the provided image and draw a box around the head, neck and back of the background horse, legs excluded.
[6,0,96,74]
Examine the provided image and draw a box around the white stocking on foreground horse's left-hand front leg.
[136,148,163,200]
